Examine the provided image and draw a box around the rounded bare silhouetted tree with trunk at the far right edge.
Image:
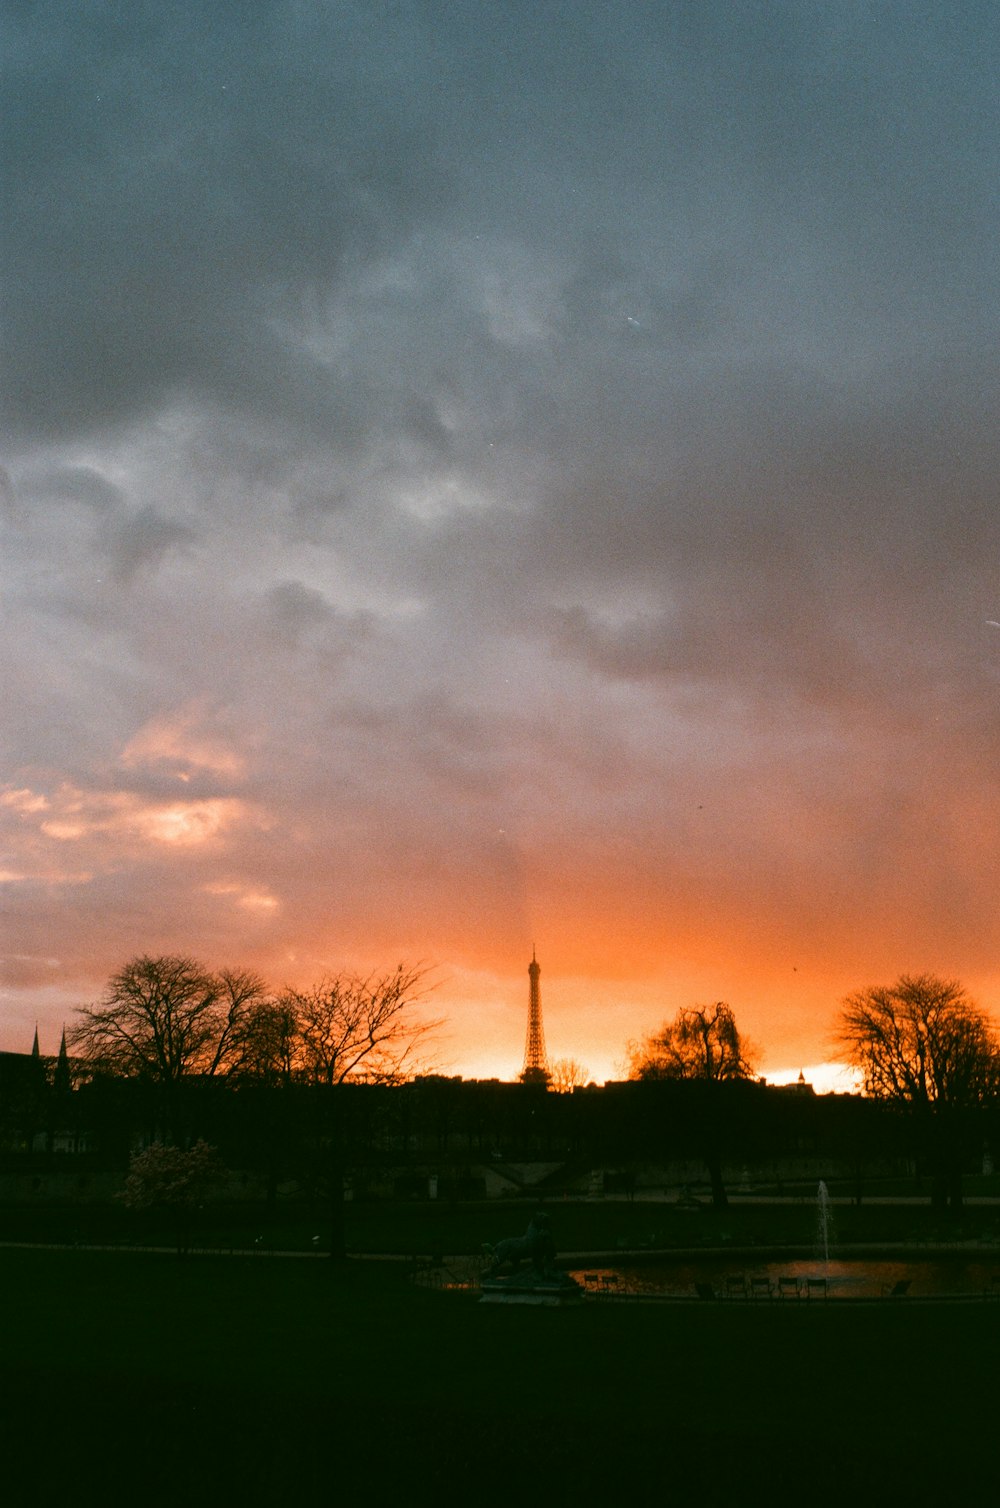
[839,974,1000,1208]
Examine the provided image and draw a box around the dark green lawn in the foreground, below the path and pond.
[0,1252,1000,1505]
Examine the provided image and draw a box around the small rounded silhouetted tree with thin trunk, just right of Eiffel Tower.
[627,1000,753,1208]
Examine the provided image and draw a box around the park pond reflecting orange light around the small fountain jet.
[572,1256,1000,1301]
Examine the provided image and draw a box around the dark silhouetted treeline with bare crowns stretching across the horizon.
[7,956,1000,1206]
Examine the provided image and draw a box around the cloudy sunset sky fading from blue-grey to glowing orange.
[0,0,1000,1080]
